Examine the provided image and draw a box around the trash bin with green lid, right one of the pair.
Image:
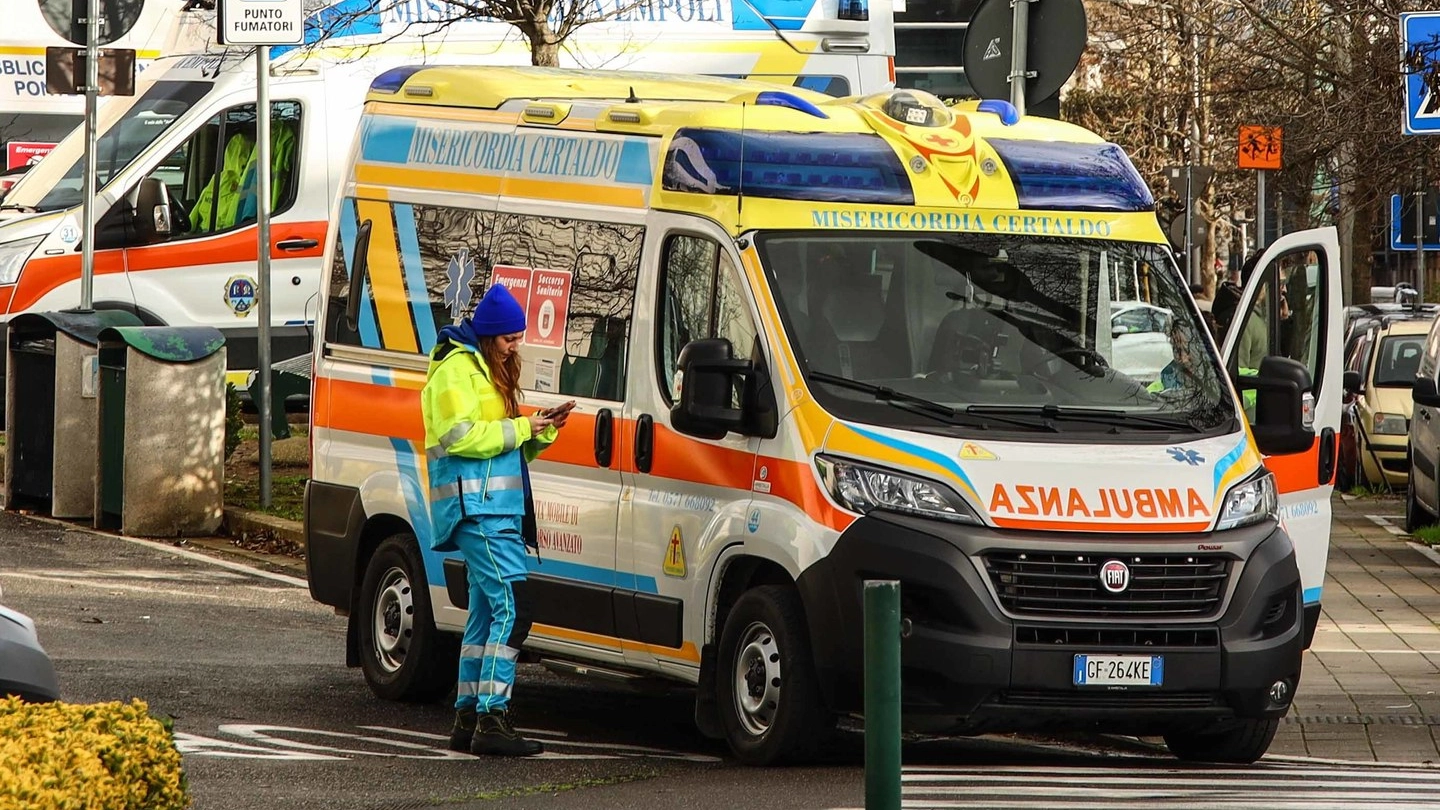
[94,326,225,538]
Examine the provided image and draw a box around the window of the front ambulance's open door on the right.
[1236,249,1325,386]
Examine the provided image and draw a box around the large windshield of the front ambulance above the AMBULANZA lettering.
[757,232,1237,434]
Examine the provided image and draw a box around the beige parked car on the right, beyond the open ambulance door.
[1336,313,1434,487]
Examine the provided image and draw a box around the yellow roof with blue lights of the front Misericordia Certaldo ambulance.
[357,65,1161,241]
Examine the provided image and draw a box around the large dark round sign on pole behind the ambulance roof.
[960,0,1086,104]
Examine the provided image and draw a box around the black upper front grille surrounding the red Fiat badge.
[985,552,1231,618]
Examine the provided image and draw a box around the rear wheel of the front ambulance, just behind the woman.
[354,532,459,703]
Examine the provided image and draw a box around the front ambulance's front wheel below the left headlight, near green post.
[716,585,835,765]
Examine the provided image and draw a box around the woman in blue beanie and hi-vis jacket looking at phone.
[420,284,575,757]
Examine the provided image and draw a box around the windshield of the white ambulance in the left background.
[4,81,213,210]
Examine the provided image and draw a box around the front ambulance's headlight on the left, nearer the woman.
[815,455,981,523]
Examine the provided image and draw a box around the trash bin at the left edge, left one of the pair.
[4,310,140,519]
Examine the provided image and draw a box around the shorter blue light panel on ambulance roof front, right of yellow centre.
[988,138,1155,210]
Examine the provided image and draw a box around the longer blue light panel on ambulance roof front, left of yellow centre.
[661,128,914,205]
